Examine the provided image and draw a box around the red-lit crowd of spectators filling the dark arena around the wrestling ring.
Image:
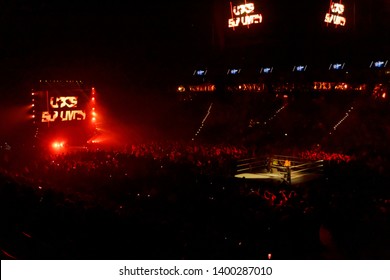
[0,90,390,259]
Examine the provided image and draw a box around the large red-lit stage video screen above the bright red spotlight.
[31,82,96,147]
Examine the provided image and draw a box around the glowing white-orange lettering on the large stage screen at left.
[42,96,87,122]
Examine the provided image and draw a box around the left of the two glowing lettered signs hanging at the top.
[228,1,263,30]
